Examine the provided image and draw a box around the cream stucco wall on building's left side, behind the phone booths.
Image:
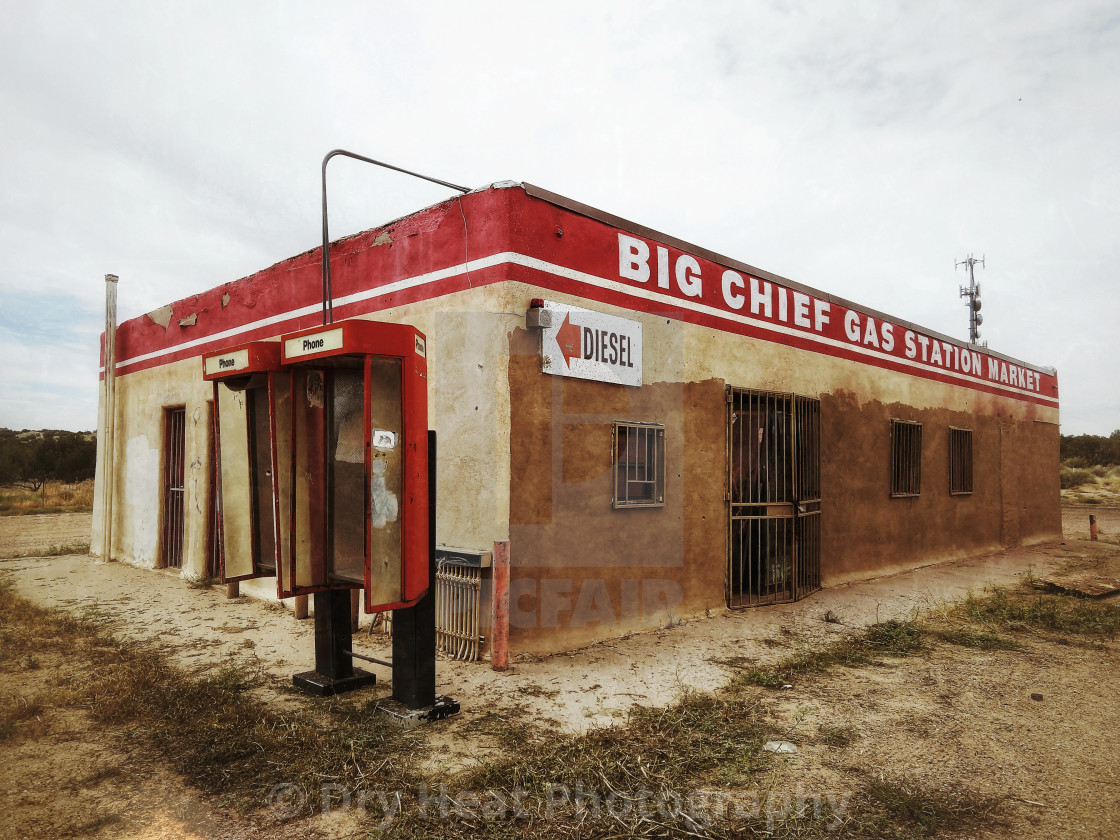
[93,284,523,597]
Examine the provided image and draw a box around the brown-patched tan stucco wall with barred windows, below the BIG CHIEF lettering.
[510,286,1061,653]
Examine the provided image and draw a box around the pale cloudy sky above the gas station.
[0,0,1120,435]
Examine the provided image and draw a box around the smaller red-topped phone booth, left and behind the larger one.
[203,342,289,584]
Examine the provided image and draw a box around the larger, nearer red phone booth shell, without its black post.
[277,320,430,613]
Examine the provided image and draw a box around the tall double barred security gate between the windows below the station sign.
[727,388,821,607]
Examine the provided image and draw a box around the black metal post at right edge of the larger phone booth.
[393,431,439,711]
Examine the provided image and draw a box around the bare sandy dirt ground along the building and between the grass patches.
[0,505,1120,839]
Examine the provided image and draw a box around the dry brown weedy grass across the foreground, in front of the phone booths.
[0,579,1084,840]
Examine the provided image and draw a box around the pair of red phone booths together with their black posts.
[205,320,443,719]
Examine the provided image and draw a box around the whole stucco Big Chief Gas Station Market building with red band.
[93,183,1061,654]
